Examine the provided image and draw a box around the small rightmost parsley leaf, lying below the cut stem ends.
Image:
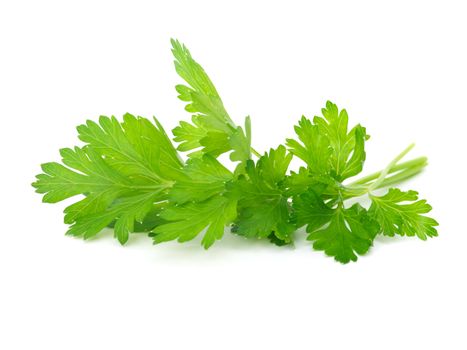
[369,188,438,240]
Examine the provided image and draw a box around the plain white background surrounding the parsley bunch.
[0,0,467,350]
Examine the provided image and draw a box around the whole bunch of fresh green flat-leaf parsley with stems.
[33,40,438,263]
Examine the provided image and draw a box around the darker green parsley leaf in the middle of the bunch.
[230,146,295,243]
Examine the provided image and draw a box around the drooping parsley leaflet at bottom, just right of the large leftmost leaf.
[153,196,237,249]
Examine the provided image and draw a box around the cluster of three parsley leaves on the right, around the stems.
[287,102,437,263]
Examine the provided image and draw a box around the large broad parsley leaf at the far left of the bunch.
[33,114,182,244]
